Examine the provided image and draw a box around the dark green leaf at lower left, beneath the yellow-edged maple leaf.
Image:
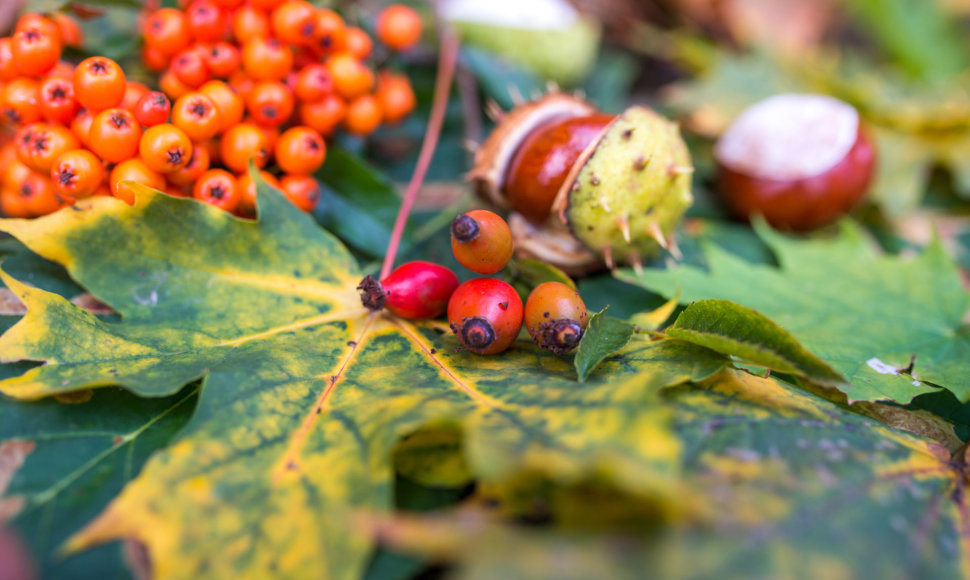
[0,380,198,579]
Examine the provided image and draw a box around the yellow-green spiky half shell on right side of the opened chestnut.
[563,106,693,263]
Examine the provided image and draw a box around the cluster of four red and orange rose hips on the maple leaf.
[358,209,588,354]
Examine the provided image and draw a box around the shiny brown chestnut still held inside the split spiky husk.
[502,113,615,224]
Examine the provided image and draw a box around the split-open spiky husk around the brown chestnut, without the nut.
[469,93,693,275]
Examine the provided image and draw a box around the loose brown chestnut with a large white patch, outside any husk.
[715,95,876,231]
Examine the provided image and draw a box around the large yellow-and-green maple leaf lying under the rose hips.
[0,183,726,578]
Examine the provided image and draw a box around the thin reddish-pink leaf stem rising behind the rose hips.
[379,27,458,280]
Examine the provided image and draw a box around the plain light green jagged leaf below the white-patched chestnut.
[621,222,970,403]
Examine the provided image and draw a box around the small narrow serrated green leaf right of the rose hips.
[665,300,845,385]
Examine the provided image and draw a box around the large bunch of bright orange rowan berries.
[0,0,421,217]
